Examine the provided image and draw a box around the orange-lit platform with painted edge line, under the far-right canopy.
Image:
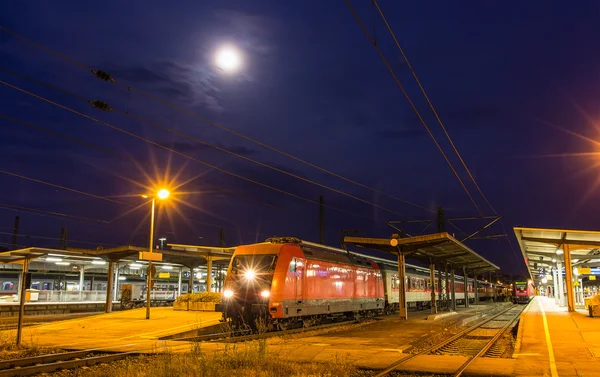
[513,297,600,377]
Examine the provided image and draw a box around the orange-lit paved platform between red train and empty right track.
[269,303,506,370]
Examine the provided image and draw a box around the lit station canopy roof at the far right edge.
[514,227,600,279]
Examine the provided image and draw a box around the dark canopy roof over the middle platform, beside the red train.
[344,232,500,273]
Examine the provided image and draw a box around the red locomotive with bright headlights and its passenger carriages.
[216,237,493,329]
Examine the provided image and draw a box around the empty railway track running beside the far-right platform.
[373,306,524,377]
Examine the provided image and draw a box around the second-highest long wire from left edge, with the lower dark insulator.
[0,67,408,217]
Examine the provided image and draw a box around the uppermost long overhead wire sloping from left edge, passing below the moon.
[0,26,435,213]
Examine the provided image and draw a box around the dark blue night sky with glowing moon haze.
[0,0,600,273]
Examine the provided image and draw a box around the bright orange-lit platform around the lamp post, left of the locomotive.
[11,307,221,351]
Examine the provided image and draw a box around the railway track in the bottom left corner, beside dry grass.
[0,350,139,377]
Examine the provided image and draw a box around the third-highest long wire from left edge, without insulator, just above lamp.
[0,80,380,220]
